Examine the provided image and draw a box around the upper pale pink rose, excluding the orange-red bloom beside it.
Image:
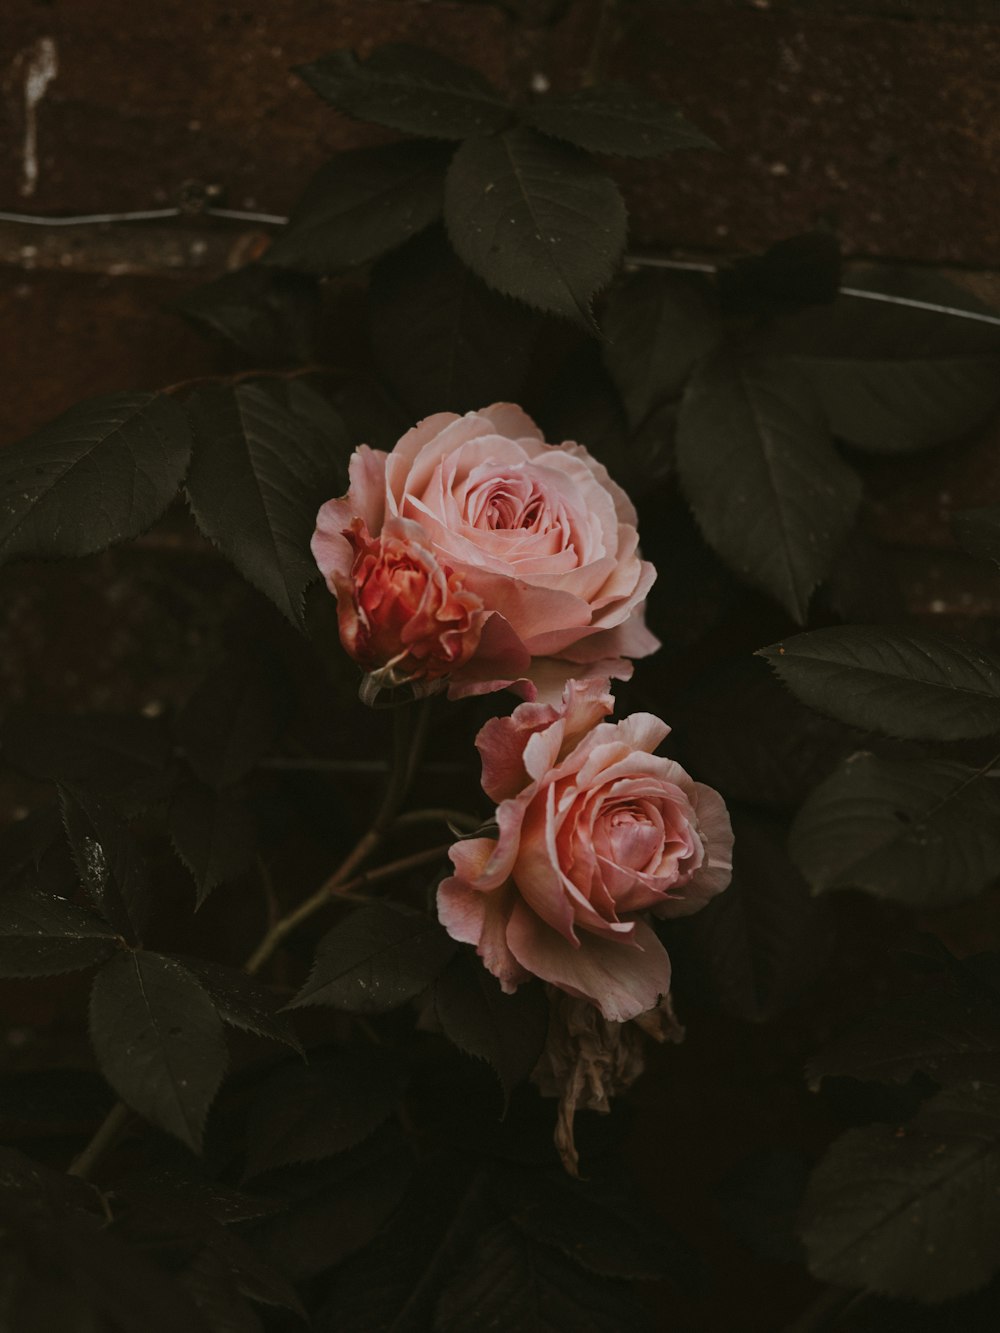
[312,403,659,698]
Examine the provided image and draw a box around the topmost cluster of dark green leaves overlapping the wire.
[265,45,715,328]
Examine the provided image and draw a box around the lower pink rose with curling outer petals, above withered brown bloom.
[437,680,732,1022]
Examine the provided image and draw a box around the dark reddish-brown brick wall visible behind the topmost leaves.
[0,0,1000,443]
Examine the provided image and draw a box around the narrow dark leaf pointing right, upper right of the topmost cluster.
[523,83,717,157]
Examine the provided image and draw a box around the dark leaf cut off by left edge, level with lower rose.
[0,884,120,977]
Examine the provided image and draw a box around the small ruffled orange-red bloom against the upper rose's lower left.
[332,519,484,696]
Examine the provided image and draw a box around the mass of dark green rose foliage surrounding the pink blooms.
[0,36,1000,1333]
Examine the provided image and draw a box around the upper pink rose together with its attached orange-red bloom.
[312,403,659,698]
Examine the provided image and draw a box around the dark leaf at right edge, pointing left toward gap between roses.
[760,625,1000,741]
